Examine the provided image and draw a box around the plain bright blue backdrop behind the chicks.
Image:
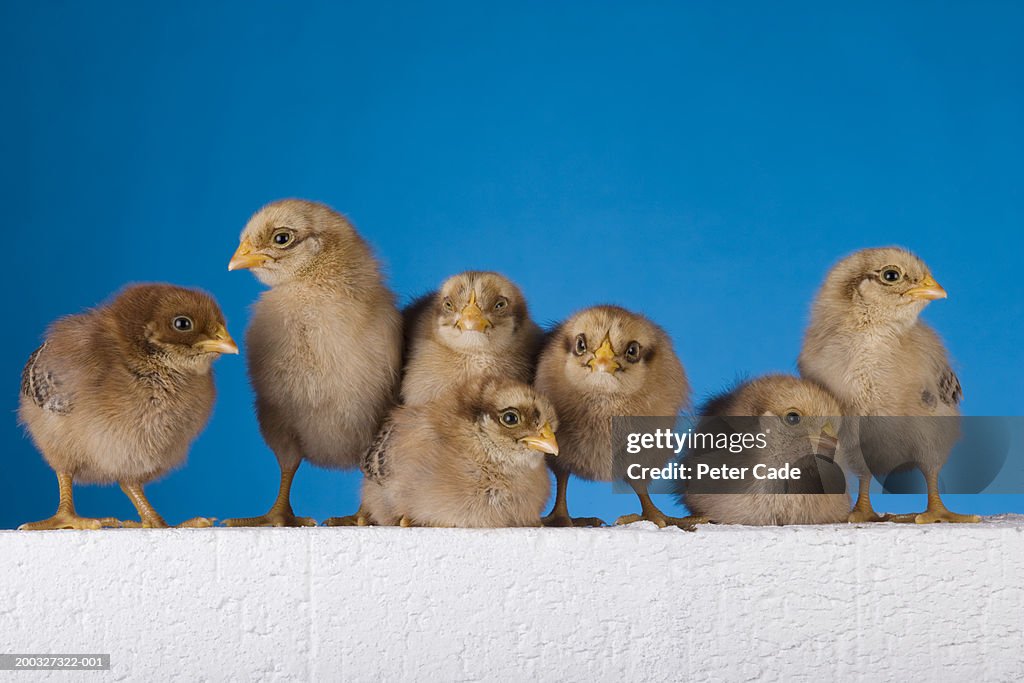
[0,1,1024,527]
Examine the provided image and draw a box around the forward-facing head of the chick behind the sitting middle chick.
[434,270,529,351]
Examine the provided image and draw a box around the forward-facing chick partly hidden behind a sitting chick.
[401,271,542,405]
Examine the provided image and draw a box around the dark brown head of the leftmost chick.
[111,285,239,372]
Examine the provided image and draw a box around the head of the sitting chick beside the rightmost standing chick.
[731,375,843,459]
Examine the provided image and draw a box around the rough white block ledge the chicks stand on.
[0,516,1024,682]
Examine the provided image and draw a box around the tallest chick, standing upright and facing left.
[224,200,401,526]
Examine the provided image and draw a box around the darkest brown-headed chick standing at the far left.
[18,285,239,529]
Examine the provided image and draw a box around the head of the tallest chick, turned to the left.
[227,200,357,287]
